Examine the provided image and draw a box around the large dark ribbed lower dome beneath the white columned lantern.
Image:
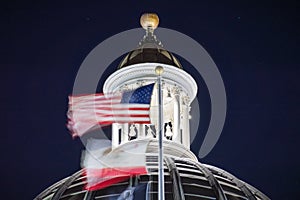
[36,141,269,200]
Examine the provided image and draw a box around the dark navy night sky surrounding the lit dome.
[0,0,300,199]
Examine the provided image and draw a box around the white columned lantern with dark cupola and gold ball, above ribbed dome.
[103,13,197,150]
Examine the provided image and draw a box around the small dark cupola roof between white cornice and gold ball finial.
[118,45,182,69]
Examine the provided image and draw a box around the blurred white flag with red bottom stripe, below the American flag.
[82,139,149,191]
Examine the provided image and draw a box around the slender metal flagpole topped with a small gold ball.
[155,66,165,200]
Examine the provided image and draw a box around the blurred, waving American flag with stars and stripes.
[67,83,154,137]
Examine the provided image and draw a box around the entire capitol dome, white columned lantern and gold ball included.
[35,14,269,200]
